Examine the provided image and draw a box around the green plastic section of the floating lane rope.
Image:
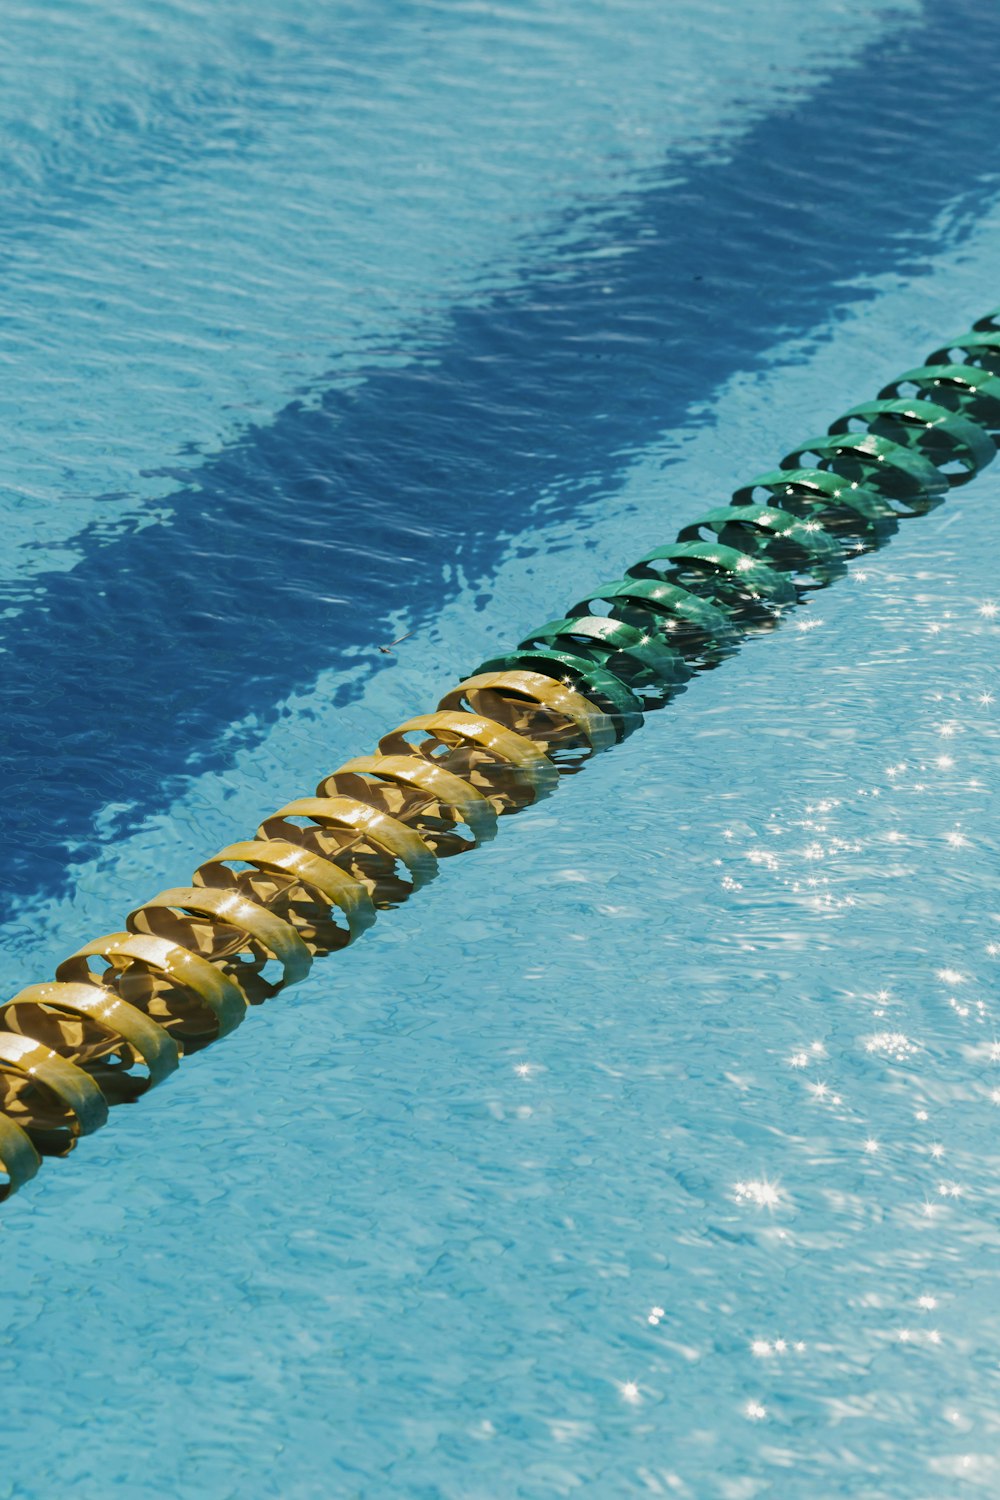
[478,309,1000,735]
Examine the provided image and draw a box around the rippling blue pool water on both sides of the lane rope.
[0,0,1000,1500]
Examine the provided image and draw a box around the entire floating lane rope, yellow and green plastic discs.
[0,308,1000,1199]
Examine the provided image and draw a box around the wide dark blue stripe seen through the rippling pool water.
[0,0,1000,894]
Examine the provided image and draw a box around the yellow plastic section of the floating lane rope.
[0,672,575,1199]
